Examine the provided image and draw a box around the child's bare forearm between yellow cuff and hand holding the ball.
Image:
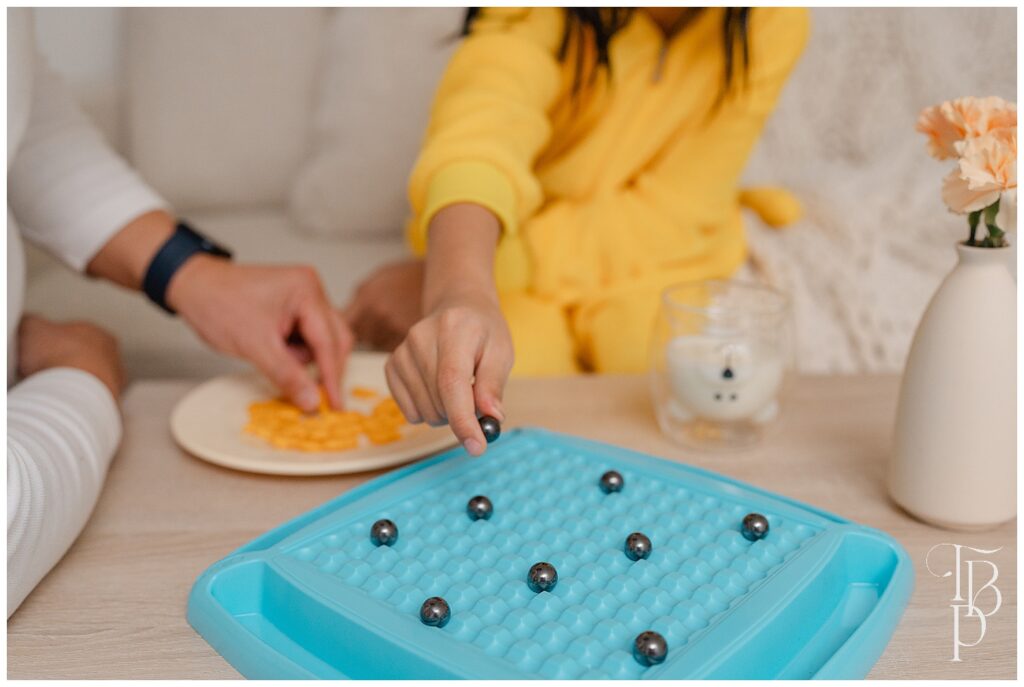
[423,203,501,312]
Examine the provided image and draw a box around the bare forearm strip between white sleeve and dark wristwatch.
[86,210,174,290]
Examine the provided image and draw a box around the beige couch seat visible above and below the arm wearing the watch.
[26,211,408,379]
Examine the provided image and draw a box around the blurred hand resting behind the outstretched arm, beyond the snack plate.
[342,260,424,351]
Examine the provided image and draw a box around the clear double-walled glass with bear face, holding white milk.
[650,280,793,449]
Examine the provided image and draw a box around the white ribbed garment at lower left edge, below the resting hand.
[7,368,121,617]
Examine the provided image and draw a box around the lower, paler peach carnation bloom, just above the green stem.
[942,127,1017,214]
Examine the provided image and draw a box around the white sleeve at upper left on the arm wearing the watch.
[7,44,167,270]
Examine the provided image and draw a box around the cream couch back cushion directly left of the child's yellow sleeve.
[290,7,465,237]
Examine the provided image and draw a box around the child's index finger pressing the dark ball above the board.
[436,331,486,456]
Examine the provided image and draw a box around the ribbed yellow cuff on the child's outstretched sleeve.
[408,161,518,255]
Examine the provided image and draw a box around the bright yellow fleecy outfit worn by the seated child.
[409,7,808,374]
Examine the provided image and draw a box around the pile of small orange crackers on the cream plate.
[245,387,406,452]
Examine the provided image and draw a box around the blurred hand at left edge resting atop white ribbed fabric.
[17,314,124,398]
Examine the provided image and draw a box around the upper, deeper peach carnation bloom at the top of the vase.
[915,95,1017,160]
